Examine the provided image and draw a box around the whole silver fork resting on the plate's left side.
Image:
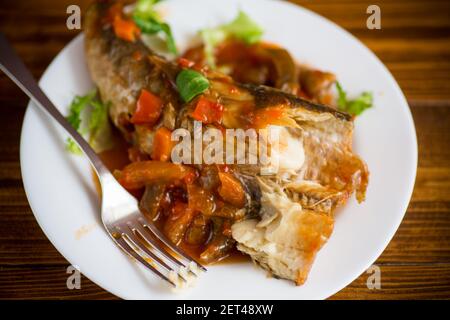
[0,34,206,287]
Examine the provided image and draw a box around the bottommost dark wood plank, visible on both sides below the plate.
[0,265,450,299]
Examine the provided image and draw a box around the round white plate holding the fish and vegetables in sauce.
[21,0,417,299]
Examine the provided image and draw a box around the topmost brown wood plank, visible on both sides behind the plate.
[0,0,450,101]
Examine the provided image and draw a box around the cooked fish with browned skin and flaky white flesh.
[85,1,368,284]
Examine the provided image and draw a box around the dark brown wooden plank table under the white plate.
[0,0,450,299]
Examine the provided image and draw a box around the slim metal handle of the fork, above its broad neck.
[0,33,111,177]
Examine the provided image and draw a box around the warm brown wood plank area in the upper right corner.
[293,0,450,101]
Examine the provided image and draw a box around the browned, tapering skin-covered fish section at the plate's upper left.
[84,1,181,140]
